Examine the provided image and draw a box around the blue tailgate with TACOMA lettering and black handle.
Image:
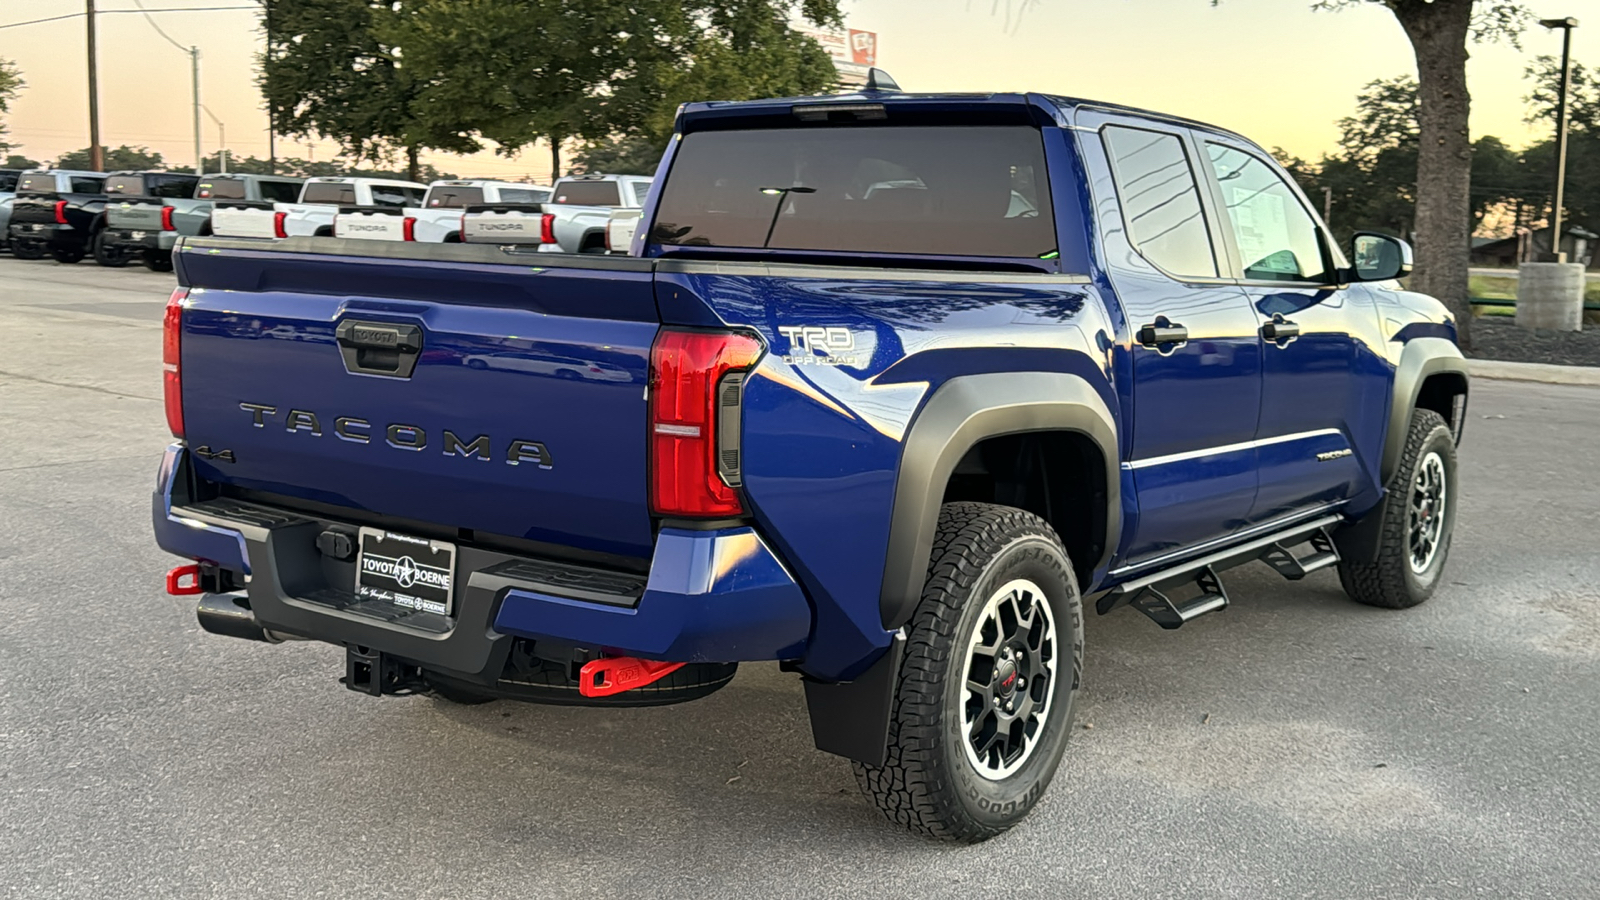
[179,239,658,557]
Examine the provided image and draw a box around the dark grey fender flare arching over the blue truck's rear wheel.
[878,372,1122,631]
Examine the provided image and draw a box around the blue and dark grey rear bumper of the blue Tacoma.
[152,444,813,684]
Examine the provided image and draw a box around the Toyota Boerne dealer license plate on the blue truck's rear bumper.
[355,528,456,617]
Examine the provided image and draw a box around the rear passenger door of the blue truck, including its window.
[1080,114,1261,564]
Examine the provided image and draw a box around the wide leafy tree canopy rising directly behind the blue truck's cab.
[386,0,840,175]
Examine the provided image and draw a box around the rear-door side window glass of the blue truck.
[1101,125,1216,279]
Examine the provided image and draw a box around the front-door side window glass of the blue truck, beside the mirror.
[1206,144,1328,283]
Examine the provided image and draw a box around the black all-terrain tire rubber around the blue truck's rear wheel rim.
[854,503,1083,842]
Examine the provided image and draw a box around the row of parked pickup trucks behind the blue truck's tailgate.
[0,170,633,265]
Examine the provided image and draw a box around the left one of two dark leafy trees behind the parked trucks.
[259,0,473,181]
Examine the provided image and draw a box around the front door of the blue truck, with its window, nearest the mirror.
[1200,135,1389,522]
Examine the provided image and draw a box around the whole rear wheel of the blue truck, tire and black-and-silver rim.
[854,503,1083,842]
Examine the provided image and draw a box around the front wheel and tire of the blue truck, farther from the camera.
[1339,410,1458,609]
